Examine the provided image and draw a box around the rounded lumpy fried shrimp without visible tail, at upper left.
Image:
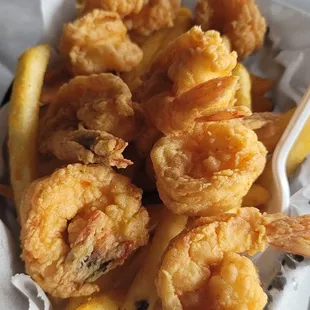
[59,10,143,75]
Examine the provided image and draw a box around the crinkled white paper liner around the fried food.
[0,0,310,310]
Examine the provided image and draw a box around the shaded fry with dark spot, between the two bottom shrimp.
[121,209,187,310]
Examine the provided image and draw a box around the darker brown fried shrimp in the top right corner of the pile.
[195,0,267,60]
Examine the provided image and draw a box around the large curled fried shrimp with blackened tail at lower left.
[21,164,149,298]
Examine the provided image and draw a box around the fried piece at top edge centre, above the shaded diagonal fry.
[124,0,181,36]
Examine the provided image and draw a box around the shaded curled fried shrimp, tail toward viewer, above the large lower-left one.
[40,73,140,168]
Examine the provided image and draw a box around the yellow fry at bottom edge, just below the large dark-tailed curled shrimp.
[66,291,124,310]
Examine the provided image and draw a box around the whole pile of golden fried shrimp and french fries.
[0,0,310,310]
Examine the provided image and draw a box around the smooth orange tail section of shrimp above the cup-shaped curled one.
[143,76,251,134]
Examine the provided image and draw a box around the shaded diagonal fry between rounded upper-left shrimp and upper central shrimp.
[121,8,193,91]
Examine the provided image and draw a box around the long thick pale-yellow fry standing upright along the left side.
[8,45,50,213]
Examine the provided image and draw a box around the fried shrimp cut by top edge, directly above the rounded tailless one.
[76,0,148,18]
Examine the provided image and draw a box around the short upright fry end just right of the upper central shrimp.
[233,63,252,110]
